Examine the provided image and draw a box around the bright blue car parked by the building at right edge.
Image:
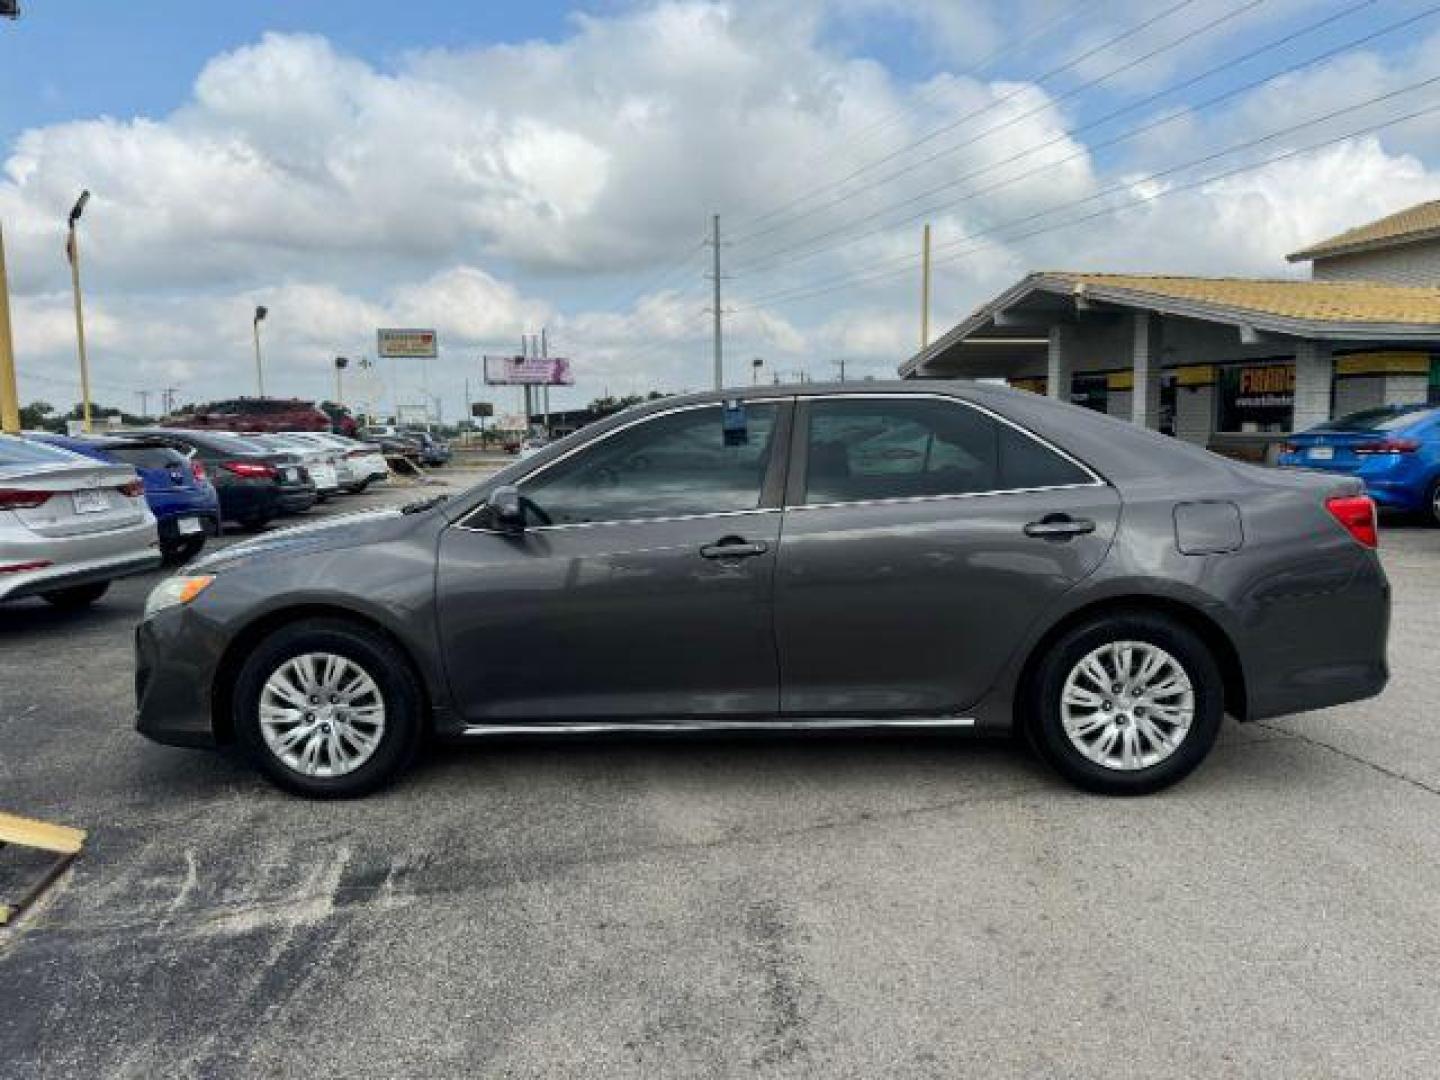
[1279,405,1440,526]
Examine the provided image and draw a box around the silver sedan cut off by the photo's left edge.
[0,435,160,608]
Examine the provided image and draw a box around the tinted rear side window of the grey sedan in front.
[802,397,1090,505]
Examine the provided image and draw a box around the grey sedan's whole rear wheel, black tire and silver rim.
[1025,613,1224,795]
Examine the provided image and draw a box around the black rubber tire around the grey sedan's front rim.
[233,619,425,799]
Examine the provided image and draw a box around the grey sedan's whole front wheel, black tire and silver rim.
[233,619,423,798]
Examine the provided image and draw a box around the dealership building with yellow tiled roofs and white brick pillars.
[900,202,1440,456]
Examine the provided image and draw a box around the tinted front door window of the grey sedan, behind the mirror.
[521,405,776,524]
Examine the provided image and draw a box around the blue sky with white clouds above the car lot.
[0,0,1440,418]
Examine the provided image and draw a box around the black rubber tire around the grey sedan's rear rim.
[1021,612,1224,795]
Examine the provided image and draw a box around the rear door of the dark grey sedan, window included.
[775,395,1119,717]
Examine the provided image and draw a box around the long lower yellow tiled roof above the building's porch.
[1040,272,1440,325]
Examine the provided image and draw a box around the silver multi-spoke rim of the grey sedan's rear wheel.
[1060,641,1195,772]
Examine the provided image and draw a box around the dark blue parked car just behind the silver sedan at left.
[26,432,220,563]
